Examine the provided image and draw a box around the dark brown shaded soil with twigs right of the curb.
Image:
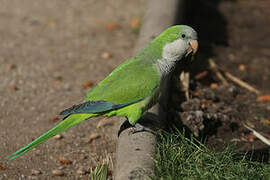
[175,0,270,162]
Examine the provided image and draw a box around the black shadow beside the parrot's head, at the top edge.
[180,0,233,74]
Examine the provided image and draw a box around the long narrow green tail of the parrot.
[7,114,97,161]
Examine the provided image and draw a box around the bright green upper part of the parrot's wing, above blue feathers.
[85,57,160,104]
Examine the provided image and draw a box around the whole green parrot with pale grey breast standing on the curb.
[7,25,198,160]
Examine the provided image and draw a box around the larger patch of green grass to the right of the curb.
[154,132,270,180]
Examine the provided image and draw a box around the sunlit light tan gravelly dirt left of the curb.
[0,0,146,180]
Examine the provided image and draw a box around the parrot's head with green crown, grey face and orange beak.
[160,25,198,61]
